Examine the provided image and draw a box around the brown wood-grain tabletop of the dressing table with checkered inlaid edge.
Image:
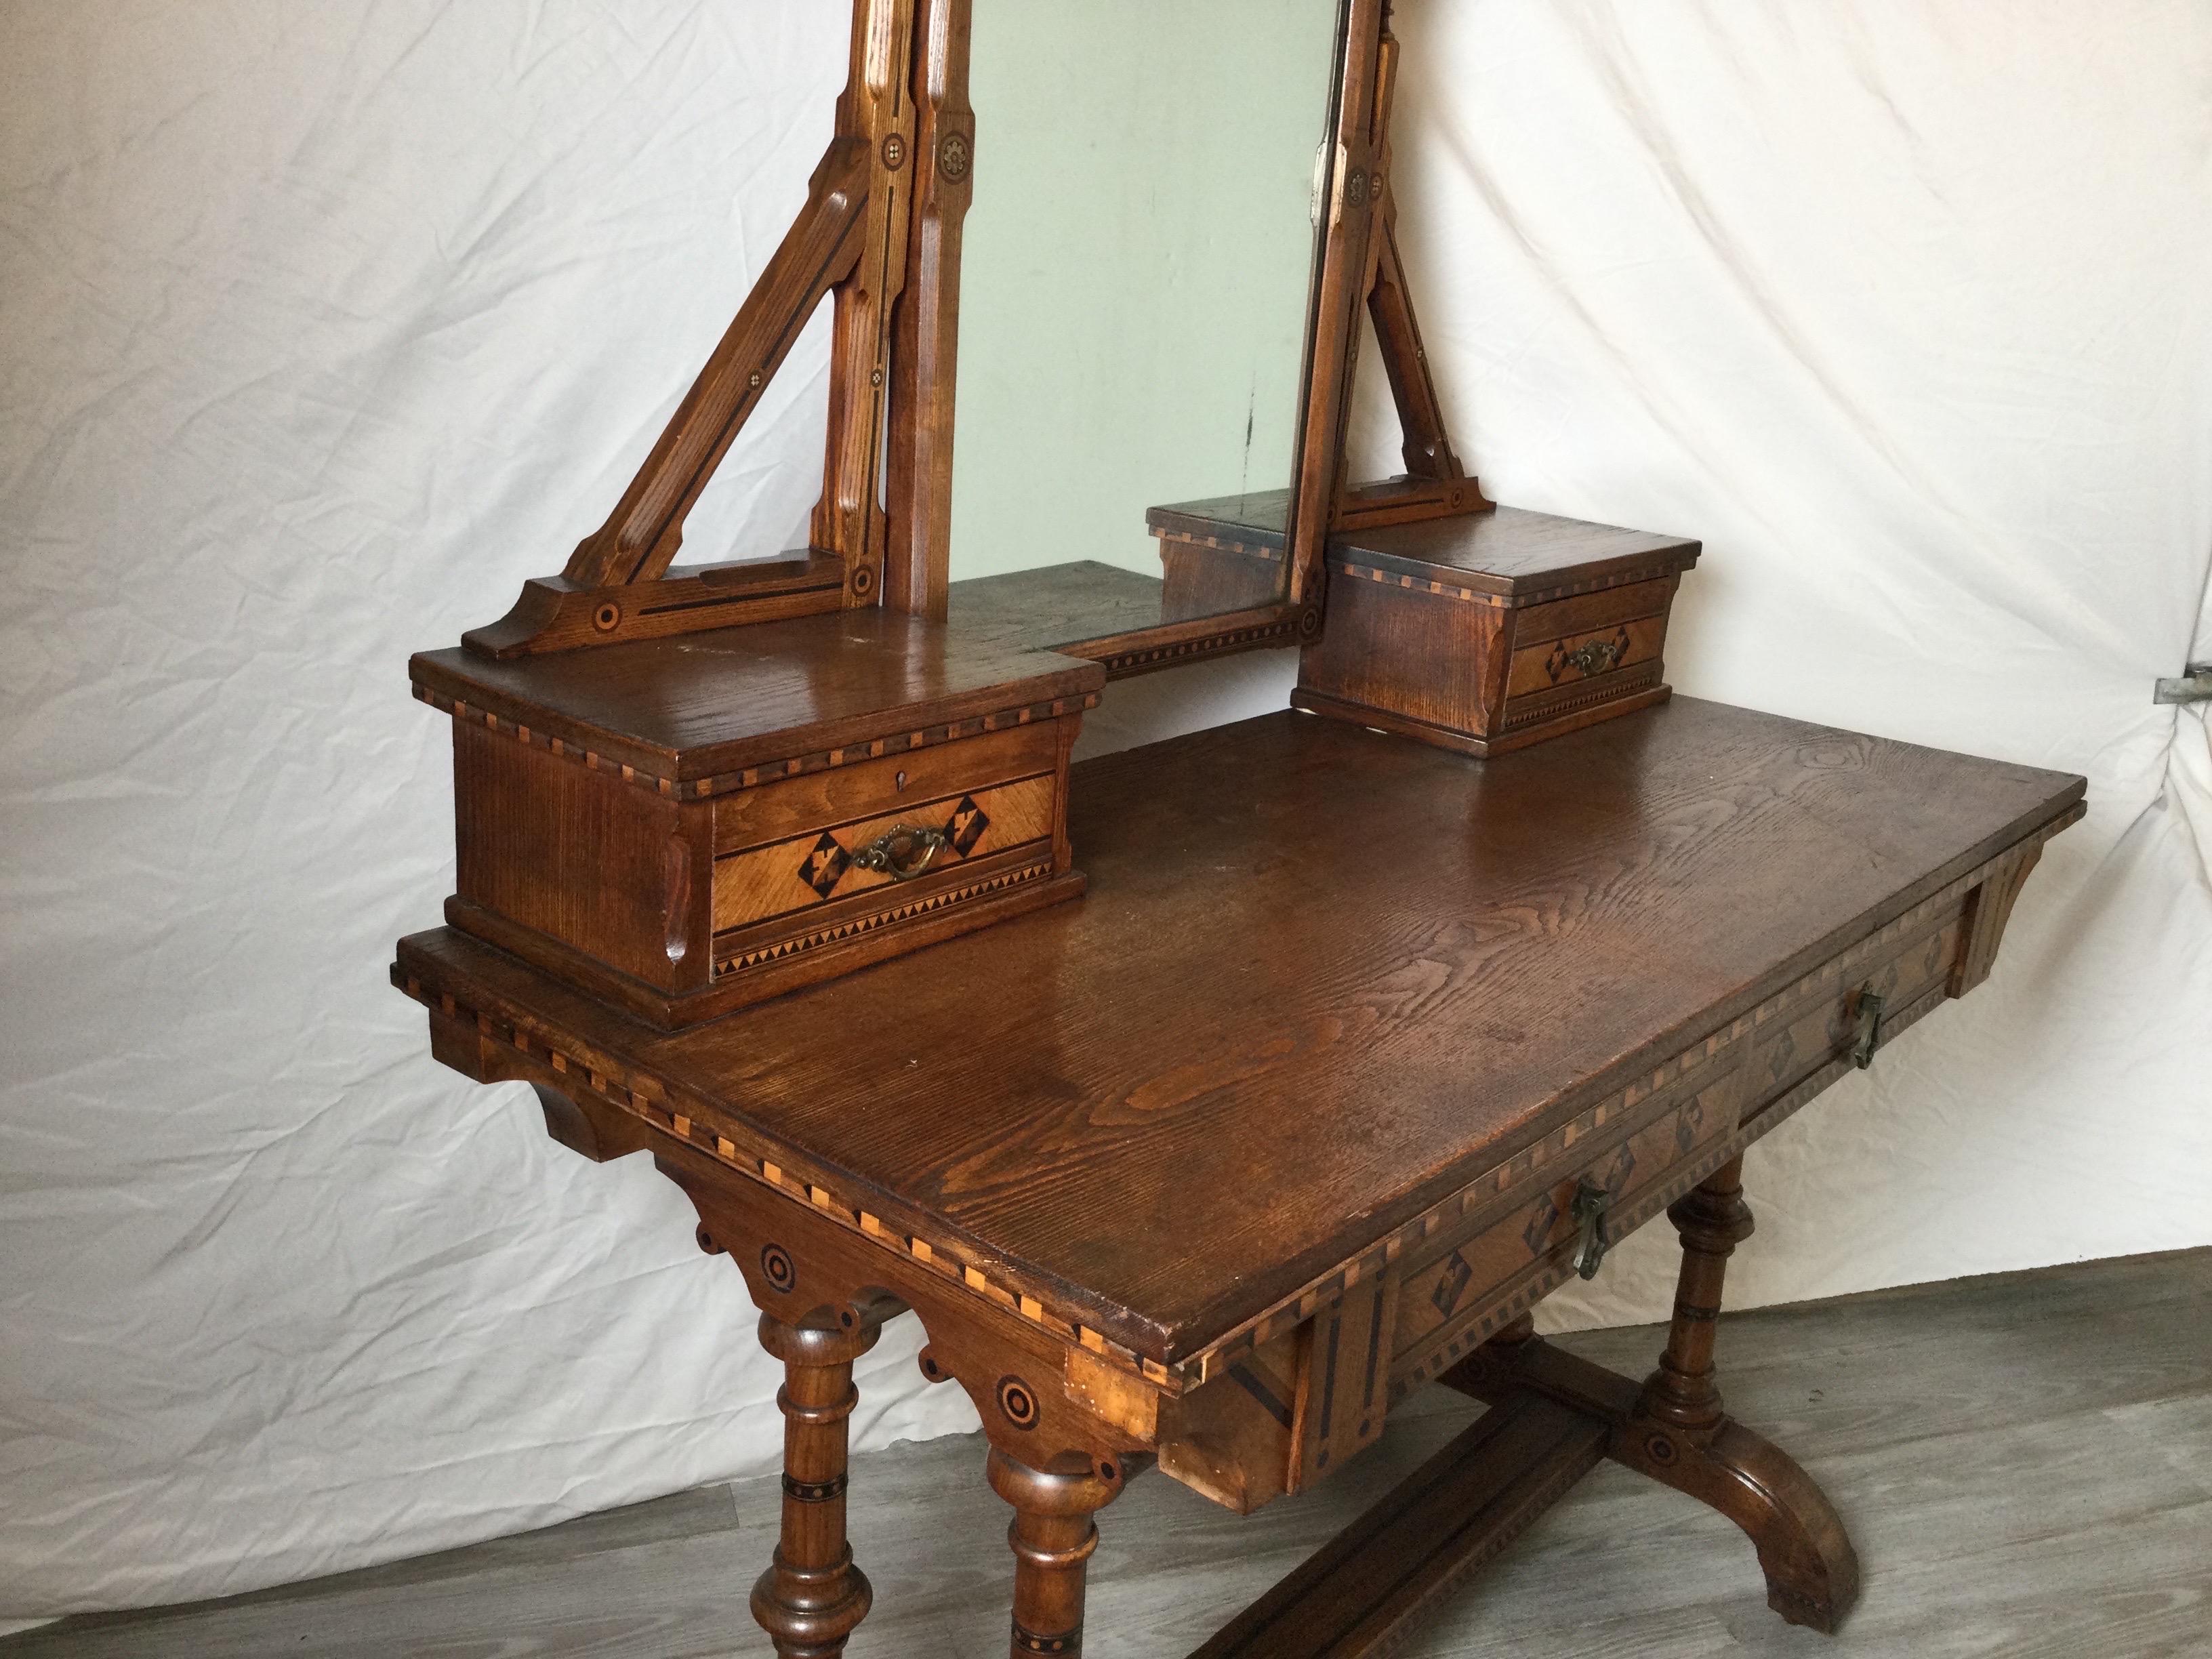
[394,699,2084,1365]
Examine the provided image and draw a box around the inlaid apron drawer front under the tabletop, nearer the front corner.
[1391,1064,1741,1382]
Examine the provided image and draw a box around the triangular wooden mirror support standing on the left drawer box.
[464,0,973,657]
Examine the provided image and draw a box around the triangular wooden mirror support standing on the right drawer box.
[1292,0,1493,602]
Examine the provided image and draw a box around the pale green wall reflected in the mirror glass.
[951,0,1338,581]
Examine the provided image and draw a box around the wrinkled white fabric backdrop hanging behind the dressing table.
[0,0,2212,1619]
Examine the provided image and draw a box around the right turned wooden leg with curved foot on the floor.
[1612,1157,1858,1635]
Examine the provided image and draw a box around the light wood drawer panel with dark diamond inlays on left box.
[714,774,1059,949]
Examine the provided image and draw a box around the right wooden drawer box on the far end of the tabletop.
[1292,506,1699,754]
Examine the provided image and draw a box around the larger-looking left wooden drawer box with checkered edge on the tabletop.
[409,611,1104,1029]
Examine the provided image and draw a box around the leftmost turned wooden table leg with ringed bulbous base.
[752,1307,882,1659]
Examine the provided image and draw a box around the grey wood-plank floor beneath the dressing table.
[17,1250,2212,1659]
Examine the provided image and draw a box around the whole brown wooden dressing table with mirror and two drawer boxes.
[392,0,2084,1659]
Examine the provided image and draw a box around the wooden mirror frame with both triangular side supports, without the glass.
[464,0,1489,675]
